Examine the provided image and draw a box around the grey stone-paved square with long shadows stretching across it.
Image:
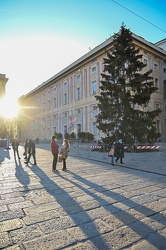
[0,144,166,250]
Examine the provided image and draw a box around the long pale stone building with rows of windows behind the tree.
[19,34,166,141]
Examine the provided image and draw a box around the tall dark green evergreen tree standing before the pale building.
[96,26,161,144]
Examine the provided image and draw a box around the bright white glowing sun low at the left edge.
[0,97,19,119]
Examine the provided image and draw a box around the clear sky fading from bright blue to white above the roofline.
[0,0,166,102]
